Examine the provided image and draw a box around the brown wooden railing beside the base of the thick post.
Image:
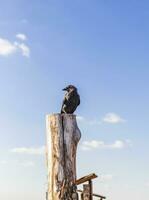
[75,173,106,200]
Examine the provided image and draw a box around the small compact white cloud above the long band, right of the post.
[103,113,125,124]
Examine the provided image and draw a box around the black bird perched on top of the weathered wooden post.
[61,85,80,114]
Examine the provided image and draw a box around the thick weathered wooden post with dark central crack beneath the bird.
[46,114,81,200]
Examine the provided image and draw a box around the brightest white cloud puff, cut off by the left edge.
[0,38,17,56]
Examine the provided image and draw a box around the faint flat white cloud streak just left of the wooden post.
[10,146,45,155]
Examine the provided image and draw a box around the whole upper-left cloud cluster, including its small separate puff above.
[0,34,30,57]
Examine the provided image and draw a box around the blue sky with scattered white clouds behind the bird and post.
[0,0,149,200]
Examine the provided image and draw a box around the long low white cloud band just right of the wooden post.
[81,140,130,151]
